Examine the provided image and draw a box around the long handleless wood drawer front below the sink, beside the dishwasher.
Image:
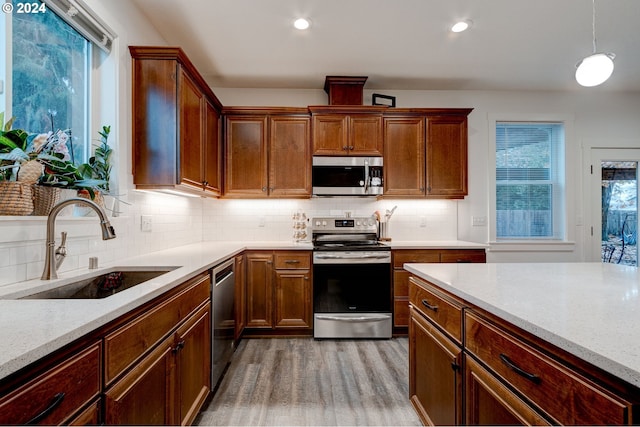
[104,274,211,384]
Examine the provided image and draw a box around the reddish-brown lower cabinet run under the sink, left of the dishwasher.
[0,273,211,425]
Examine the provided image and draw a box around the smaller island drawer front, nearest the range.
[409,277,462,344]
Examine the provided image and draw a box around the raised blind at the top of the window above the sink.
[41,0,115,53]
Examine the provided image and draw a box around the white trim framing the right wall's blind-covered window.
[487,113,582,252]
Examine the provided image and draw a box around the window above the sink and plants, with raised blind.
[0,0,114,163]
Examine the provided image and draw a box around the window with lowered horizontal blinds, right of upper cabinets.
[495,122,565,239]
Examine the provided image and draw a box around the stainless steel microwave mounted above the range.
[311,156,384,196]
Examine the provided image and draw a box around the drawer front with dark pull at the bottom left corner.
[0,343,101,425]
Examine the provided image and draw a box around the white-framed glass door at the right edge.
[588,148,640,266]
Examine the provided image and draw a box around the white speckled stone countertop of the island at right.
[405,263,640,387]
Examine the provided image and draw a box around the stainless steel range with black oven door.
[311,218,393,338]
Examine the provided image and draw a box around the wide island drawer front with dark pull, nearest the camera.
[465,312,631,425]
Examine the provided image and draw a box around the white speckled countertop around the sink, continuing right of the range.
[0,241,485,379]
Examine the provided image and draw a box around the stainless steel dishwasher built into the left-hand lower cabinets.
[211,259,236,389]
